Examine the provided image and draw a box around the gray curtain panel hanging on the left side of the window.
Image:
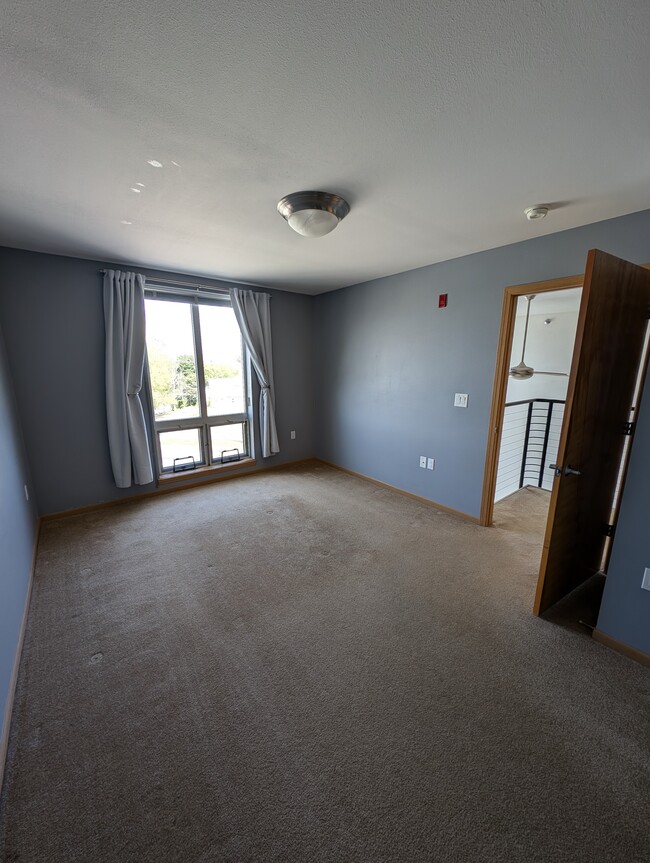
[104,270,153,488]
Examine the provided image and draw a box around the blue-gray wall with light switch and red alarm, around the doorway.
[315,211,650,652]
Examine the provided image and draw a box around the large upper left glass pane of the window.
[144,300,201,420]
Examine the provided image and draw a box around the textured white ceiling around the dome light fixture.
[0,0,650,293]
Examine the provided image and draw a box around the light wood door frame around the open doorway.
[479,273,585,527]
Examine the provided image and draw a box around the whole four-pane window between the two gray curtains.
[145,289,249,473]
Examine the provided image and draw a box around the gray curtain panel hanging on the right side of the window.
[230,288,280,458]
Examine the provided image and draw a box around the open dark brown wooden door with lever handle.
[534,250,650,614]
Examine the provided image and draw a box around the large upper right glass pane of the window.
[199,306,246,416]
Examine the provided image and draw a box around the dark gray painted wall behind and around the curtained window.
[0,249,314,515]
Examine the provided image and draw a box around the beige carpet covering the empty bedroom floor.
[0,466,650,863]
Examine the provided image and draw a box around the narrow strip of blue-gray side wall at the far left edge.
[0,320,37,752]
